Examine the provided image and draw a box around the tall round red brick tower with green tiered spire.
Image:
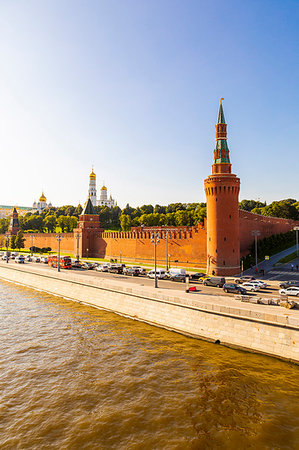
[204,99,240,276]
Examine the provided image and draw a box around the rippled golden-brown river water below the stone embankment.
[0,282,299,450]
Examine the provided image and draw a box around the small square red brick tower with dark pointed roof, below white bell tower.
[74,198,104,258]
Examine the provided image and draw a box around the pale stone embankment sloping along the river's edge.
[0,263,299,363]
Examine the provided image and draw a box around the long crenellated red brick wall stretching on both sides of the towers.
[0,210,299,268]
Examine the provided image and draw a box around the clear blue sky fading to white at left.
[0,0,299,207]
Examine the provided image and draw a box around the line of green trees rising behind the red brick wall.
[0,199,299,234]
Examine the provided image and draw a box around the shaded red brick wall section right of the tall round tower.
[239,209,299,256]
